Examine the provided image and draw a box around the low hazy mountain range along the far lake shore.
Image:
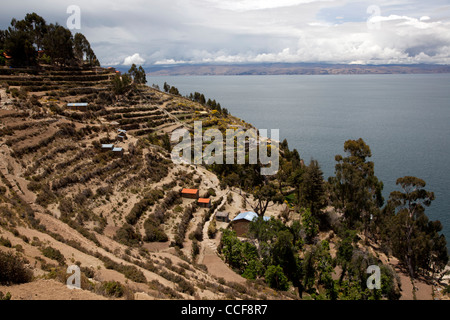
[142,63,450,76]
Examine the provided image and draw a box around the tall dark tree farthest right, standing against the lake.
[388,176,448,298]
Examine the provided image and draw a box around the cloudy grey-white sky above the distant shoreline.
[0,0,450,66]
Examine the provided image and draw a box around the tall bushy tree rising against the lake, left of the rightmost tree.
[329,138,384,235]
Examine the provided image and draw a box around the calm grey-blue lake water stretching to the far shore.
[151,74,450,244]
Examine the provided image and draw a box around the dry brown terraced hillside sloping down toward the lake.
[0,67,444,300]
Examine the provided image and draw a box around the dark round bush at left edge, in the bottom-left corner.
[0,252,33,285]
